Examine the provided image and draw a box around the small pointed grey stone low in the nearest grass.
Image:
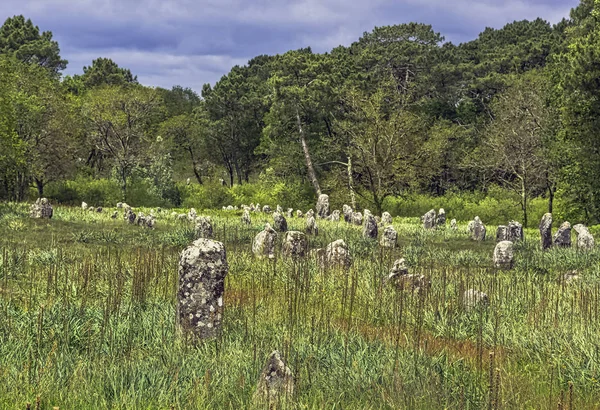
[254,350,294,409]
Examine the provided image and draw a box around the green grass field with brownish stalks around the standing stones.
[0,204,600,409]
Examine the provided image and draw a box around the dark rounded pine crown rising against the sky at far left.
[0,15,68,76]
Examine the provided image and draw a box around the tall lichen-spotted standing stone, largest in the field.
[177,238,229,340]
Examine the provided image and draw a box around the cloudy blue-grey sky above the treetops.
[0,0,579,92]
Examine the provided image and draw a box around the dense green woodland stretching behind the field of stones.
[0,0,600,225]
